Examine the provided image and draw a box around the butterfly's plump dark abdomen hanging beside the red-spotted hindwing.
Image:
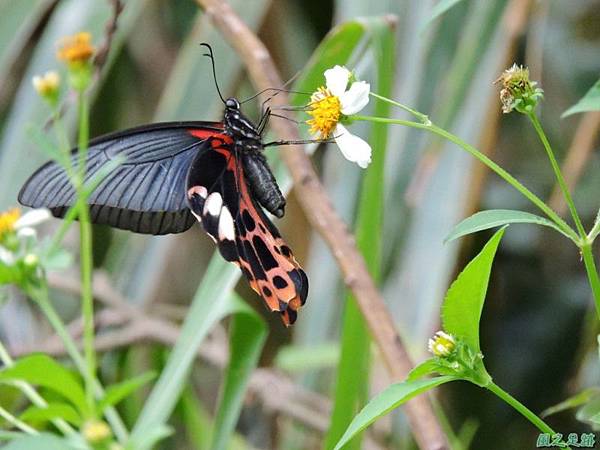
[243,152,285,218]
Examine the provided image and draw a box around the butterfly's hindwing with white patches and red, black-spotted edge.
[188,136,308,325]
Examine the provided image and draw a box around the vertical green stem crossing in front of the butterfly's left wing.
[75,92,97,418]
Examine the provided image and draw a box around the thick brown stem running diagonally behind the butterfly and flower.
[196,0,448,450]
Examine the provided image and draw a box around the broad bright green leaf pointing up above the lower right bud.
[442,227,506,353]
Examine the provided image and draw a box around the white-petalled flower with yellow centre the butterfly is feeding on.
[306,66,371,169]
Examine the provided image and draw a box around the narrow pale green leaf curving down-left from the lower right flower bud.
[334,376,458,450]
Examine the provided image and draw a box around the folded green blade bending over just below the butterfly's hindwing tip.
[210,296,267,450]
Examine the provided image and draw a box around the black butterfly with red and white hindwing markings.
[18,98,308,326]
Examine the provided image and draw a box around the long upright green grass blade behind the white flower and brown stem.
[325,18,394,449]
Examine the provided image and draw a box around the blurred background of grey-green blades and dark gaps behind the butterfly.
[0,0,600,450]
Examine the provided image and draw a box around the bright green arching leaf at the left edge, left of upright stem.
[0,354,88,416]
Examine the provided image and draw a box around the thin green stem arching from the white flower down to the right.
[352,115,580,245]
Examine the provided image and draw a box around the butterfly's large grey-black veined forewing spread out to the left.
[19,122,222,234]
